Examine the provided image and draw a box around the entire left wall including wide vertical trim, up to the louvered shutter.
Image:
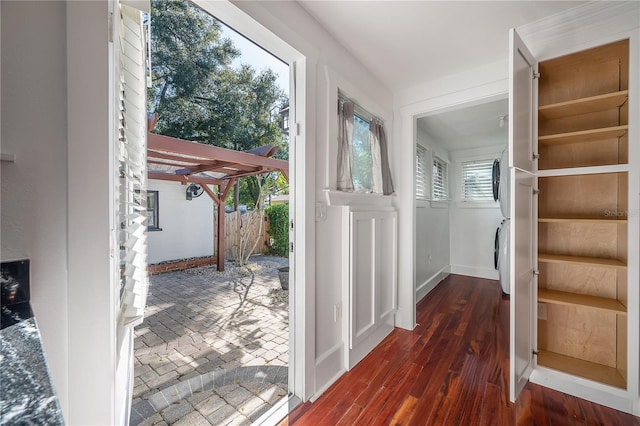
[0,1,115,424]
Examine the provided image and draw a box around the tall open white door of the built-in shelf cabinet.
[509,29,538,401]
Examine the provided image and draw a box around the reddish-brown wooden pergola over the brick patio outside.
[147,133,289,271]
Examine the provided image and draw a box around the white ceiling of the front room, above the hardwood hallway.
[299,0,585,92]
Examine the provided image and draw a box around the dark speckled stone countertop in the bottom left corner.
[0,314,64,425]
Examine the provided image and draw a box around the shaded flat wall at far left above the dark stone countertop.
[0,1,70,413]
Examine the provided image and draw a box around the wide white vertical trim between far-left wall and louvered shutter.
[65,2,119,424]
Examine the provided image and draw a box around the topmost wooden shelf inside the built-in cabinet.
[538,90,629,120]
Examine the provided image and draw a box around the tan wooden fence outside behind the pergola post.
[213,211,269,260]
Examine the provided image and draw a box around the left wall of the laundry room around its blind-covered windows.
[415,130,451,302]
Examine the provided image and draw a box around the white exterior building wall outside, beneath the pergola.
[147,179,214,264]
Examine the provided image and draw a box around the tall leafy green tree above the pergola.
[148,0,288,158]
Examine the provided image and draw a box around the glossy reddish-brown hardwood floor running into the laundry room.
[281,275,640,426]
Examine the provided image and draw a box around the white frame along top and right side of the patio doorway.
[192,0,315,410]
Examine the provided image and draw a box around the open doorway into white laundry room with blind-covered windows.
[413,95,508,302]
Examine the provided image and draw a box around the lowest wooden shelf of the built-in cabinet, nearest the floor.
[538,350,627,389]
